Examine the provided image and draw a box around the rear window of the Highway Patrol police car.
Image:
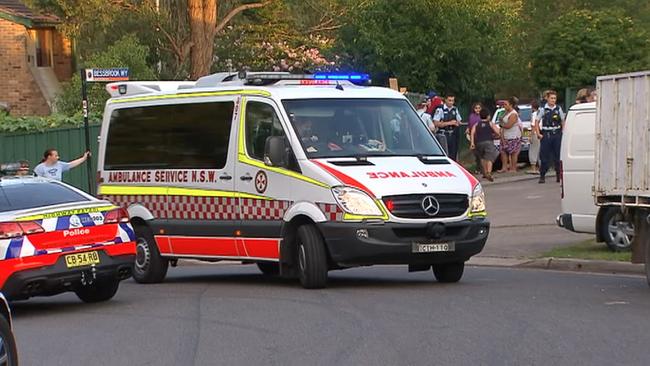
[0,182,89,212]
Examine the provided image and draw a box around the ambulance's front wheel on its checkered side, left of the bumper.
[297,225,327,289]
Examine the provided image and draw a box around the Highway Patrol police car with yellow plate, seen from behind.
[0,170,135,302]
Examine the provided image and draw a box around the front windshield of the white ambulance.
[283,99,444,158]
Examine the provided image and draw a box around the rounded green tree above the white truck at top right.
[531,10,650,90]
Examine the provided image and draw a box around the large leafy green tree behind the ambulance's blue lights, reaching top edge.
[337,0,522,98]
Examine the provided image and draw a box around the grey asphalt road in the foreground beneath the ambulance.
[14,264,650,366]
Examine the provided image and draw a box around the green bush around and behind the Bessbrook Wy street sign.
[57,35,156,115]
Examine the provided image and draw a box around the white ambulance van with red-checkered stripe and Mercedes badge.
[98,73,490,288]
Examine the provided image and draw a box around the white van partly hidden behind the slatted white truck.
[557,103,634,251]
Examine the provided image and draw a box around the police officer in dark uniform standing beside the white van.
[539,90,565,183]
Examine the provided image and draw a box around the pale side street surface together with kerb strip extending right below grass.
[467,172,645,275]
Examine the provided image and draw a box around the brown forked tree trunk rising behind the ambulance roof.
[187,0,272,79]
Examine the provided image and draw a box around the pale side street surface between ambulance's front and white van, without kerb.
[481,178,588,257]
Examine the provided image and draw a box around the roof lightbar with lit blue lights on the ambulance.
[240,73,371,85]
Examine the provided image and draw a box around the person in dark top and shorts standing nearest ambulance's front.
[469,109,499,182]
